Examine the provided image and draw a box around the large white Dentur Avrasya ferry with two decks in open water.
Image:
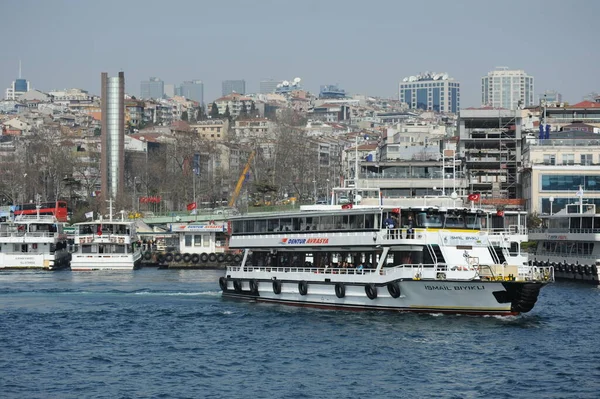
[219,198,554,315]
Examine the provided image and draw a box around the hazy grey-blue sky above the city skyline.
[0,0,600,108]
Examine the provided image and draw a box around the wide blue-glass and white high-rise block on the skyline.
[398,72,460,114]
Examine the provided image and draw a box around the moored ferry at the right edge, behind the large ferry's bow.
[529,199,600,285]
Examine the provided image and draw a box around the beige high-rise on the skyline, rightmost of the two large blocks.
[481,67,535,109]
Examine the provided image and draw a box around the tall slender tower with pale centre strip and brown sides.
[100,72,125,206]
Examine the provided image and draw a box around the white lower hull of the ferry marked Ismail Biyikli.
[220,278,542,316]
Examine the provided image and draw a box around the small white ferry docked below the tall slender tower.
[71,212,142,271]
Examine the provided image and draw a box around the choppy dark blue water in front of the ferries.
[0,269,600,398]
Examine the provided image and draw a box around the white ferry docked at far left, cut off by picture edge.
[0,214,70,270]
